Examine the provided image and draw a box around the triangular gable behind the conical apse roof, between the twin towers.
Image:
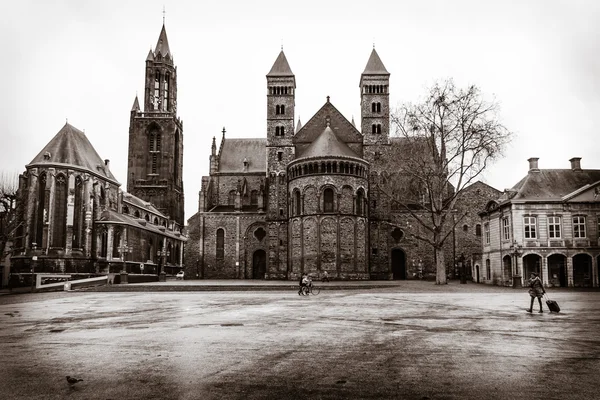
[293,101,363,151]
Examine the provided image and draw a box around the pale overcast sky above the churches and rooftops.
[0,0,600,219]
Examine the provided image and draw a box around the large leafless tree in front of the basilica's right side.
[380,80,512,284]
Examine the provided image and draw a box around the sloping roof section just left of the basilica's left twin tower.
[218,138,267,173]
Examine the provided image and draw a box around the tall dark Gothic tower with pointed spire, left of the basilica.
[127,24,184,227]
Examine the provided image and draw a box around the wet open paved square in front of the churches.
[0,282,600,399]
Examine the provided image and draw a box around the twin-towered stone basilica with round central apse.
[186,49,497,279]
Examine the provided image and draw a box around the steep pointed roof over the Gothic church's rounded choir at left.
[27,123,118,184]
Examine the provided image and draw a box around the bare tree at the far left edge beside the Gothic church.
[0,171,19,268]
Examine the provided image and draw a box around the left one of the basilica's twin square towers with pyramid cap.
[266,50,296,279]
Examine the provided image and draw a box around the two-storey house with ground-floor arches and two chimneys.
[474,158,600,287]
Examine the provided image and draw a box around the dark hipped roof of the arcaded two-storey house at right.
[508,169,600,201]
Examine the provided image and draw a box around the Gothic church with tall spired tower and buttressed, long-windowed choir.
[11,26,187,284]
